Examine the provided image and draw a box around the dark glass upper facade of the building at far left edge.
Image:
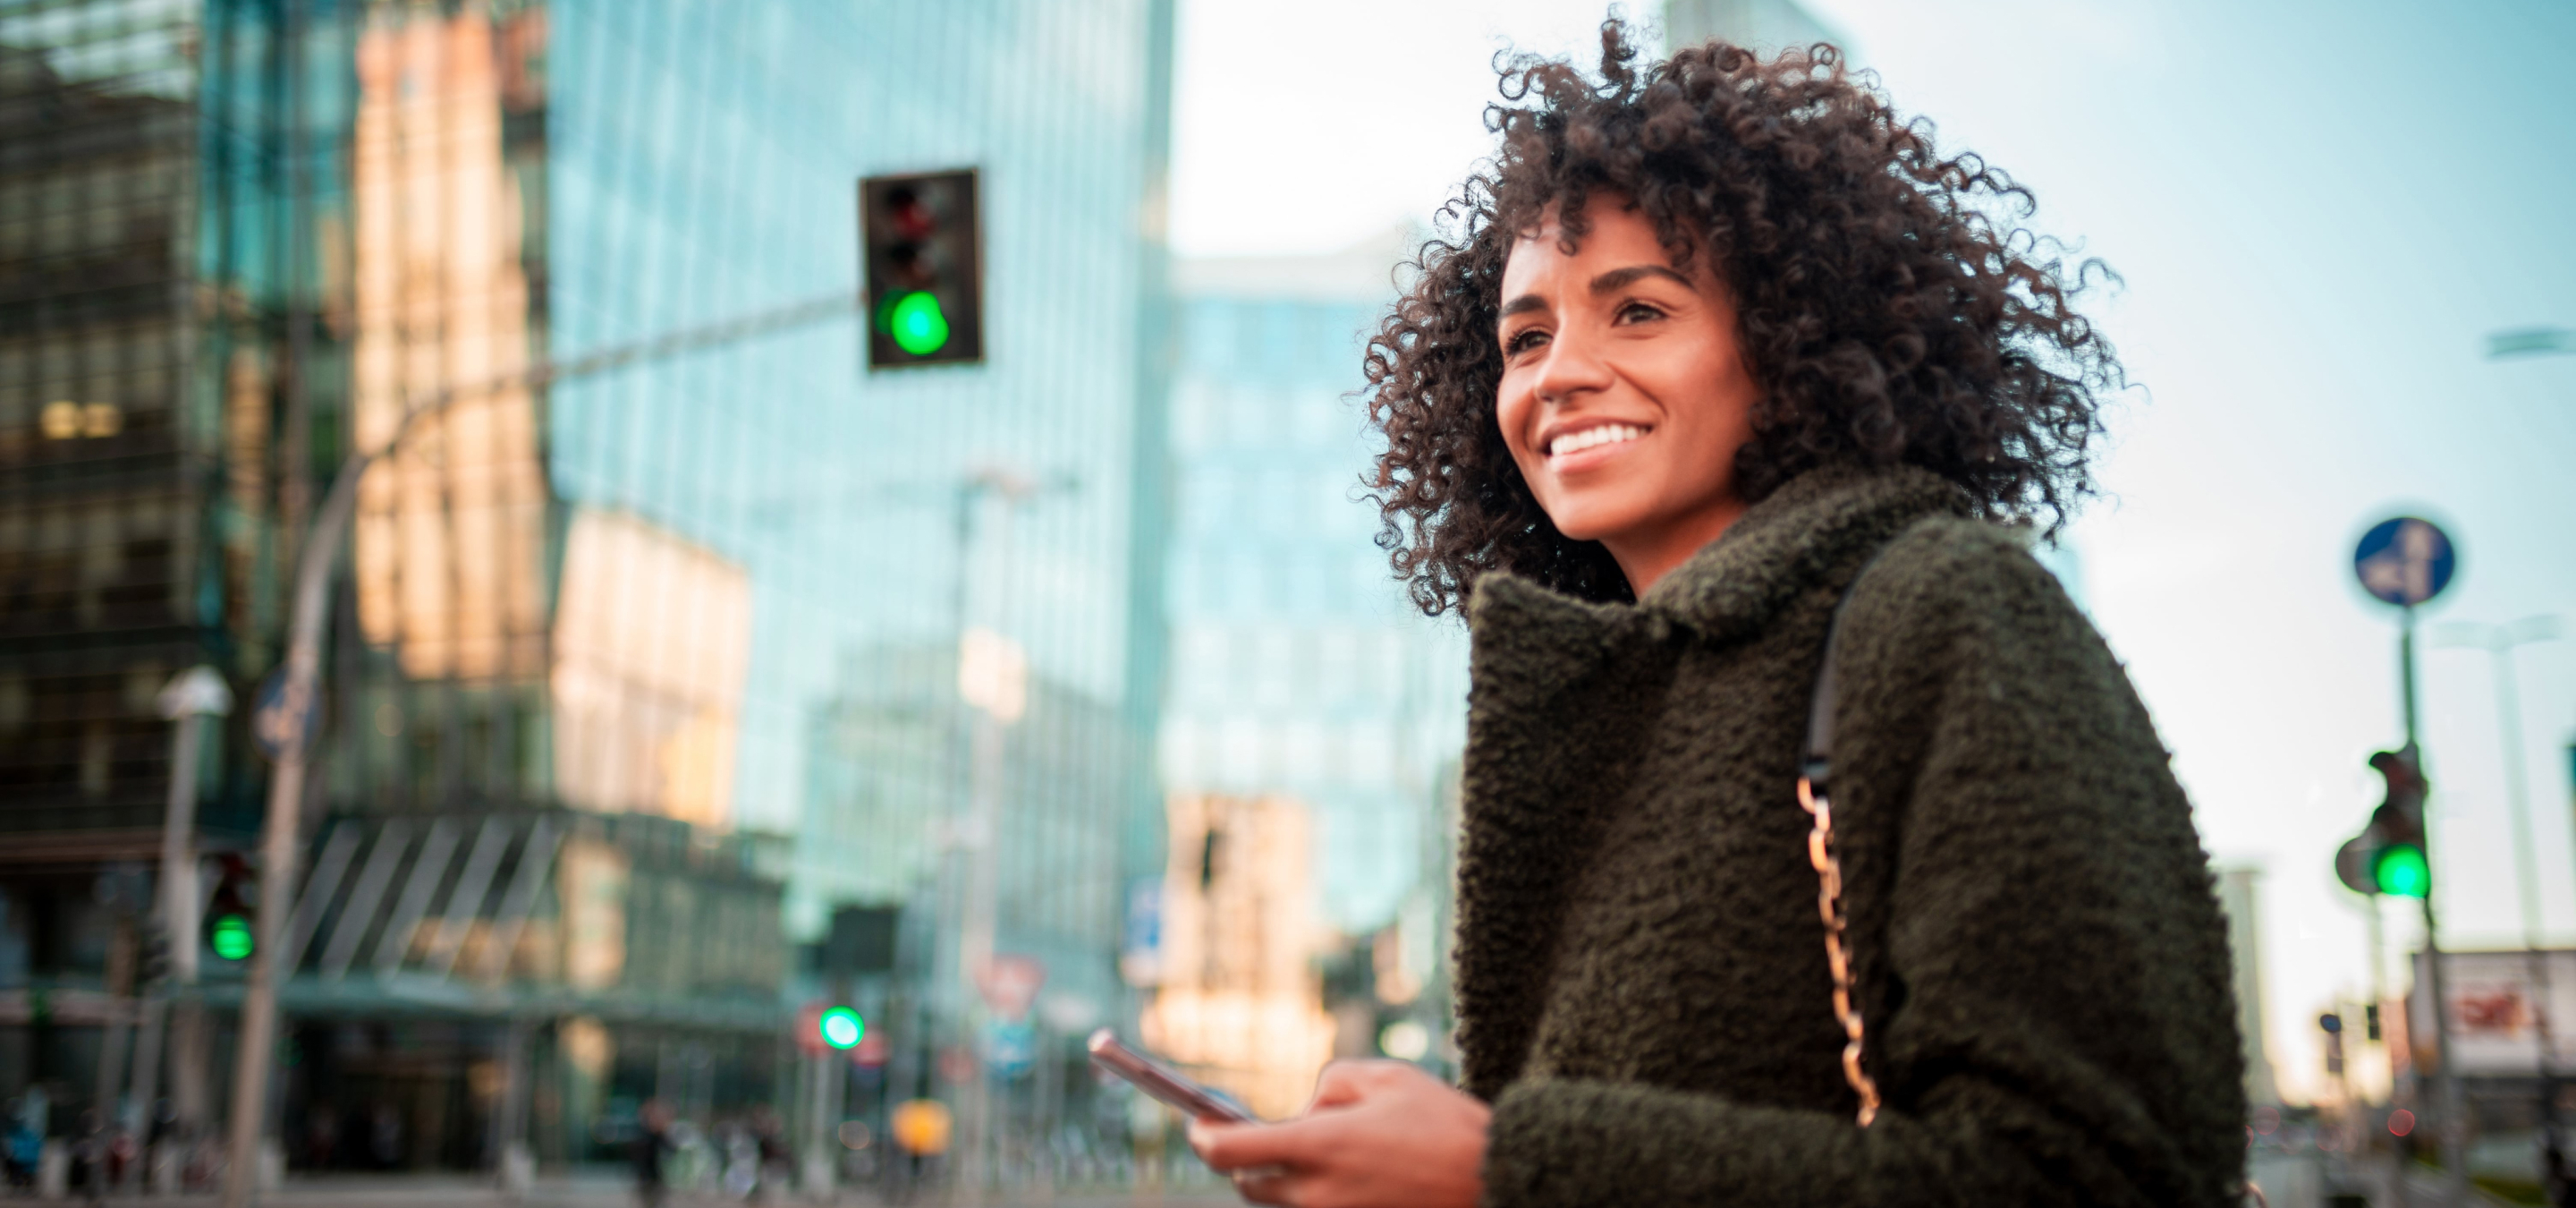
[0,3,267,839]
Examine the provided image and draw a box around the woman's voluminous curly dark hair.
[1363,15,2125,613]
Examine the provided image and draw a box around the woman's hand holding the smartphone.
[1191,1061,1494,1208]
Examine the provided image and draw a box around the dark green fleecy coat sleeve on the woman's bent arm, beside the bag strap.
[1484,520,2243,1208]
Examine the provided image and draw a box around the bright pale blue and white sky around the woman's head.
[1172,0,2576,1097]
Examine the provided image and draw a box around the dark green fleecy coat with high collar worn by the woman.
[1455,469,2246,1208]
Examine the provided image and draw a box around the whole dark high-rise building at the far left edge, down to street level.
[0,3,306,1128]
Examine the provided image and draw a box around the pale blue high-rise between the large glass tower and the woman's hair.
[1162,229,1466,935]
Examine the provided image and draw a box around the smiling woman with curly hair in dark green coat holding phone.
[1192,23,2243,1208]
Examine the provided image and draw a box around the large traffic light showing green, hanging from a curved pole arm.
[858,167,984,369]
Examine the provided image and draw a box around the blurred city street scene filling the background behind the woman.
[0,0,2576,1208]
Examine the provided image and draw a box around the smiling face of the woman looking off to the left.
[1494,196,1759,595]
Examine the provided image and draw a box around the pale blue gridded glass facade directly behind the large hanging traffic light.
[544,0,1162,957]
